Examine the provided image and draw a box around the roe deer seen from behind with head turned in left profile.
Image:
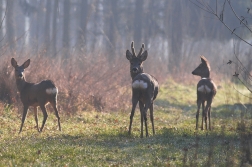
[192,56,217,130]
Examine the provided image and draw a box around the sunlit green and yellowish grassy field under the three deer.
[0,81,252,166]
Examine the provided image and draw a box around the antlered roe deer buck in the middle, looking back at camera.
[126,42,159,138]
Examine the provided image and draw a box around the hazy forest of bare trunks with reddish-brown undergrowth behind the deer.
[0,0,252,112]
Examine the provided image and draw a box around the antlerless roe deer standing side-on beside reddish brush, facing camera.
[11,58,61,133]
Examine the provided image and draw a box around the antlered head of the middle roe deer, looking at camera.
[126,41,148,79]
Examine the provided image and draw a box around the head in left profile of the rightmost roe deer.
[192,56,211,78]
